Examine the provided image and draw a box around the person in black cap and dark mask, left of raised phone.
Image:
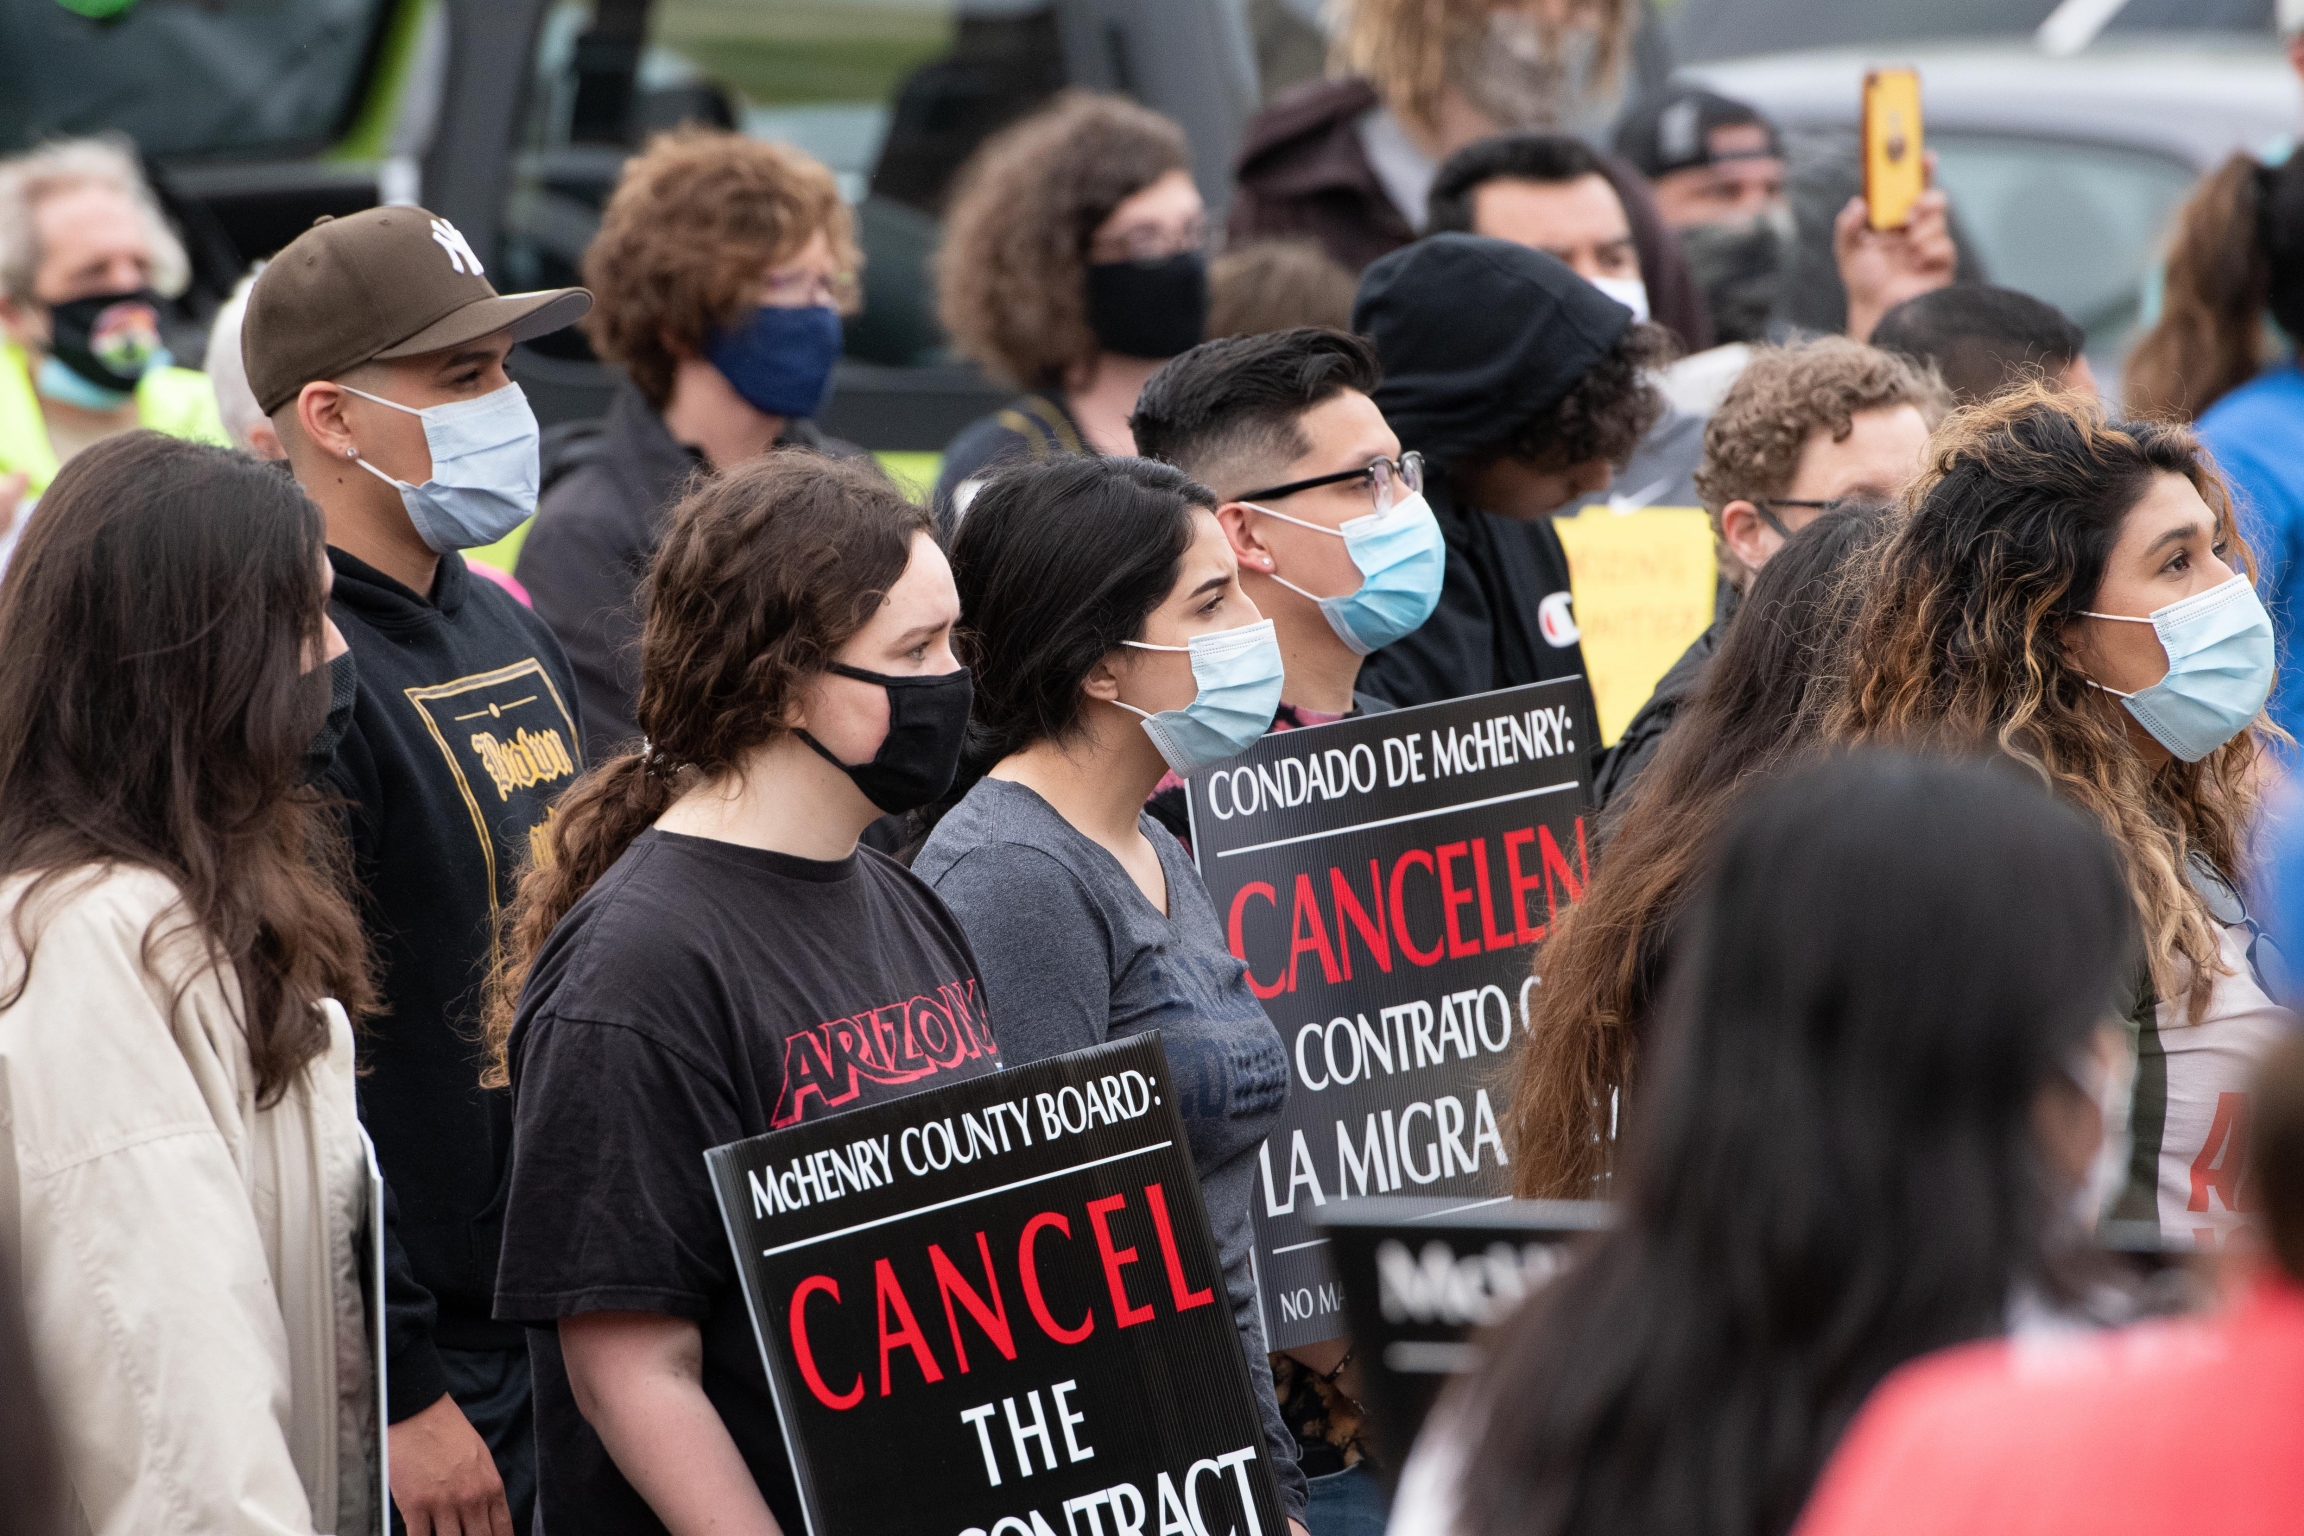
[1615,85,1799,343]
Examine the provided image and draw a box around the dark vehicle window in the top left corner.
[0,0,396,159]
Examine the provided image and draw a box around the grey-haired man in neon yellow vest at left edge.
[0,138,226,562]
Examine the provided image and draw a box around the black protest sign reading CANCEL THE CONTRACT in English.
[705,1034,1288,1536]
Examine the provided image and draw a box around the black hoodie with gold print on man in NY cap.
[327,548,583,1421]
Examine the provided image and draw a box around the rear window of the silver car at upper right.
[1928,134,2196,359]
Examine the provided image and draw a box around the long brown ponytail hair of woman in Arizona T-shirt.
[482,449,929,1087]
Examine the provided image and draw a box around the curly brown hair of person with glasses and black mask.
[935,90,1189,389]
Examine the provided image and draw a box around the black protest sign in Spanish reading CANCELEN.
[1189,677,1594,1349]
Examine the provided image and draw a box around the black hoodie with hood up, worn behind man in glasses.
[1352,235,1631,705]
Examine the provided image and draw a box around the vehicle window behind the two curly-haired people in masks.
[500,0,1064,364]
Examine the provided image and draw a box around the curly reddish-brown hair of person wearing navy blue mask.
[583,124,864,410]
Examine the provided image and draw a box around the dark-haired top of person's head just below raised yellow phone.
[1871,283,2097,405]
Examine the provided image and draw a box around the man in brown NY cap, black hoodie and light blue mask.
[242,207,592,1536]
